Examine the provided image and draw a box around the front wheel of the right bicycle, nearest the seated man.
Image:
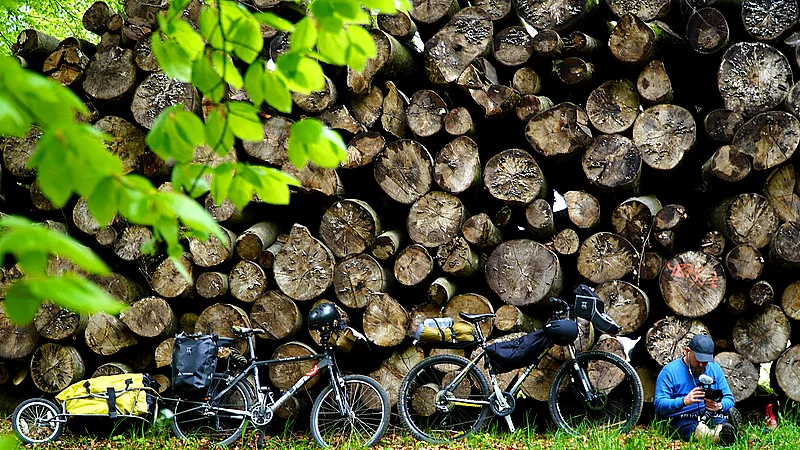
[549,352,643,434]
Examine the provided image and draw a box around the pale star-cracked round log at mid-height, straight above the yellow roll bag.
[406,191,467,248]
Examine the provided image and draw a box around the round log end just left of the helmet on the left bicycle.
[250,290,303,341]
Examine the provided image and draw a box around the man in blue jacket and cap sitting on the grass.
[654,334,741,445]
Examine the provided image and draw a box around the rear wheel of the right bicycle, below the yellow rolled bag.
[397,355,489,444]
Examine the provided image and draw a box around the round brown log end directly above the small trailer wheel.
[31,343,86,394]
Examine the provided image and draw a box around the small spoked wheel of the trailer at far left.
[11,398,64,444]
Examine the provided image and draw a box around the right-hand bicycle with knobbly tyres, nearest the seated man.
[398,285,643,444]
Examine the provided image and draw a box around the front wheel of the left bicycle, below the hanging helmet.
[311,375,390,448]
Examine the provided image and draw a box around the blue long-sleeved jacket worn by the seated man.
[653,358,734,417]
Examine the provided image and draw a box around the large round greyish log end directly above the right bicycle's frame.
[484,239,563,306]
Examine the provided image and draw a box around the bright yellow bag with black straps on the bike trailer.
[56,373,158,417]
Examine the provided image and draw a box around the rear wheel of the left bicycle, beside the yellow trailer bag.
[172,374,251,446]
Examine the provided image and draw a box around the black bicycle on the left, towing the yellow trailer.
[172,304,389,447]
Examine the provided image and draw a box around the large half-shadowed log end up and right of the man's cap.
[731,305,792,364]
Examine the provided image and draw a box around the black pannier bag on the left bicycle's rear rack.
[172,332,217,397]
